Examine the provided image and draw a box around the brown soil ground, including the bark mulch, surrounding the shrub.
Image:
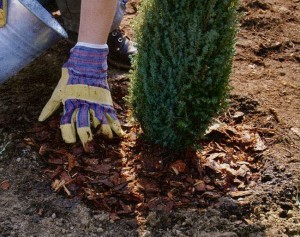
[0,0,300,237]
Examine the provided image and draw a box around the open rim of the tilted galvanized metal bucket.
[18,0,68,38]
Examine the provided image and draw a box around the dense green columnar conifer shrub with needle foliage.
[130,0,238,150]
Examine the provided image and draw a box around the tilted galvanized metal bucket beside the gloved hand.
[0,0,68,83]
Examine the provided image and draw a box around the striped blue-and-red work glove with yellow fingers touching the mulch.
[39,44,124,151]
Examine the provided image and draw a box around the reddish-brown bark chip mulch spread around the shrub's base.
[25,96,274,220]
